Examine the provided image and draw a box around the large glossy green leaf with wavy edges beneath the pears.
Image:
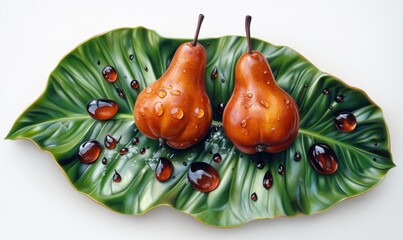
[8,28,394,227]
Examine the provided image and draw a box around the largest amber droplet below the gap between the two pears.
[187,162,220,192]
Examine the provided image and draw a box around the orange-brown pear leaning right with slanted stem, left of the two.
[134,14,212,149]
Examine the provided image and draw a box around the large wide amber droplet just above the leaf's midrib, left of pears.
[87,99,119,120]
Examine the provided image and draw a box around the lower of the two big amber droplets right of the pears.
[308,143,339,175]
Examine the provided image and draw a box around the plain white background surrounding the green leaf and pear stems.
[0,0,403,240]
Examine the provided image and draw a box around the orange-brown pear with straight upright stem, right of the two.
[223,16,299,154]
